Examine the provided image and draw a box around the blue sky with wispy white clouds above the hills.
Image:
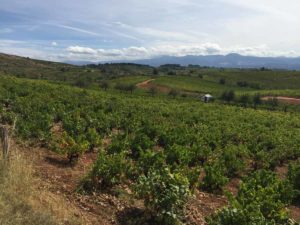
[0,0,300,62]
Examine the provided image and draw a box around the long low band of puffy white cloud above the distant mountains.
[66,43,296,62]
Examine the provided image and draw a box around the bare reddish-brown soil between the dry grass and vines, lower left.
[17,143,125,225]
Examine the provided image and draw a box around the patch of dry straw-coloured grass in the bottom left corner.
[0,151,78,225]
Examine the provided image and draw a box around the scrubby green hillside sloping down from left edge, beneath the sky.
[0,53,152,87]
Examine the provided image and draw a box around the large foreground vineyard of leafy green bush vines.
[0,73,300,225]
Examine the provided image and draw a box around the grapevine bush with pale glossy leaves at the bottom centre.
[134,168,190,225]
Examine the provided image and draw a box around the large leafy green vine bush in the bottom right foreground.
[207,170,291,225]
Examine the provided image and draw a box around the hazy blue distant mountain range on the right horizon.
[129,53,300,70]
